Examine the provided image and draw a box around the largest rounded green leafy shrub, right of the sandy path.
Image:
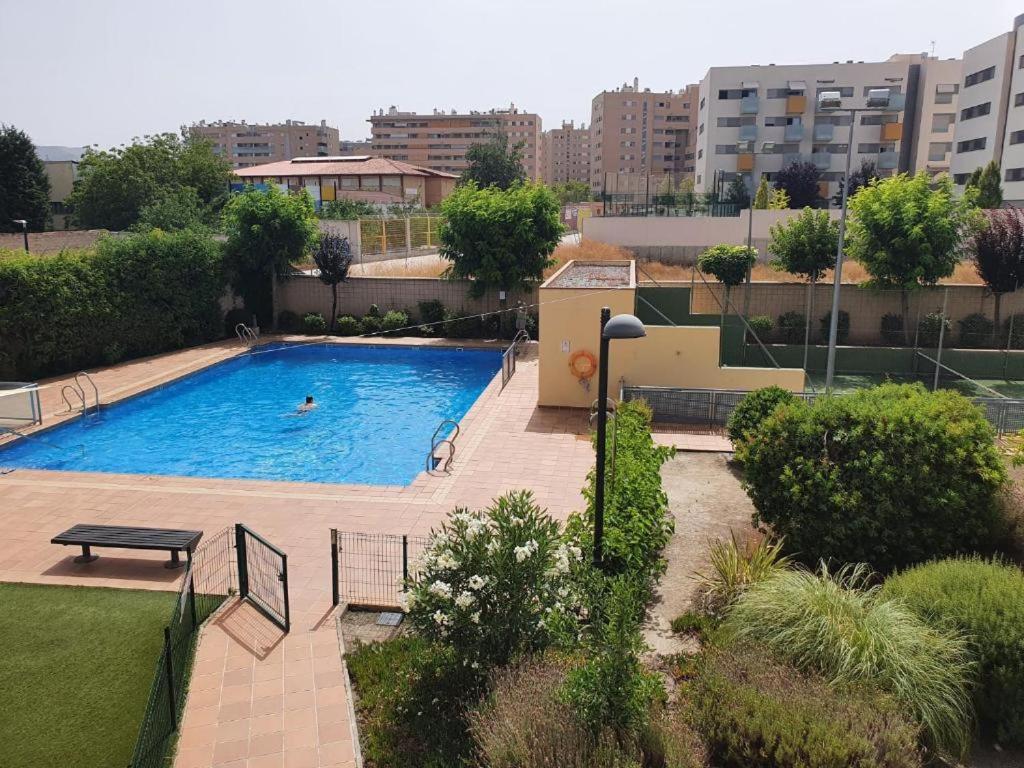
[736,384,1006,572]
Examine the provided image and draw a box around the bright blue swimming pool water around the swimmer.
[0,344,501,485]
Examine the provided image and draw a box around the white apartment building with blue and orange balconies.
[694,54,958,198]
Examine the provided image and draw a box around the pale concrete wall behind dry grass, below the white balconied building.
[583,210,840,264]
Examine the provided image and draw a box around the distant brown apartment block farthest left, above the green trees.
[188,120,340,168]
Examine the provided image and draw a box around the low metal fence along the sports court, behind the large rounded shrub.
[623,386,1024,435]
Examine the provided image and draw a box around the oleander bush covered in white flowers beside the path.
[407,490,583,676]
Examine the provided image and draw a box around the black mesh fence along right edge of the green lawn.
[129,528,237,768]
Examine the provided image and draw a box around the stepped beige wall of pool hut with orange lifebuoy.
[538,268,804,408]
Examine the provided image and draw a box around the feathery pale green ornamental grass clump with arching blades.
[722,566,971,758]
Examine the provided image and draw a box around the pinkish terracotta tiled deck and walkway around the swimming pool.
[0,338,594,768]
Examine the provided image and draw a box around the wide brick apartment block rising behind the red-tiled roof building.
[369,103,543,181]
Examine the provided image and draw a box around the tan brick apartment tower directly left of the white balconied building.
[590,78,698,194]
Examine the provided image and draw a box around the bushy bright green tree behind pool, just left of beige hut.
[439,181,563,296]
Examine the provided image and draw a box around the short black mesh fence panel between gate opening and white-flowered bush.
[331,528,430,608]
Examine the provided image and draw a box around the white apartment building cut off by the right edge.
[950,14,1024,205]
